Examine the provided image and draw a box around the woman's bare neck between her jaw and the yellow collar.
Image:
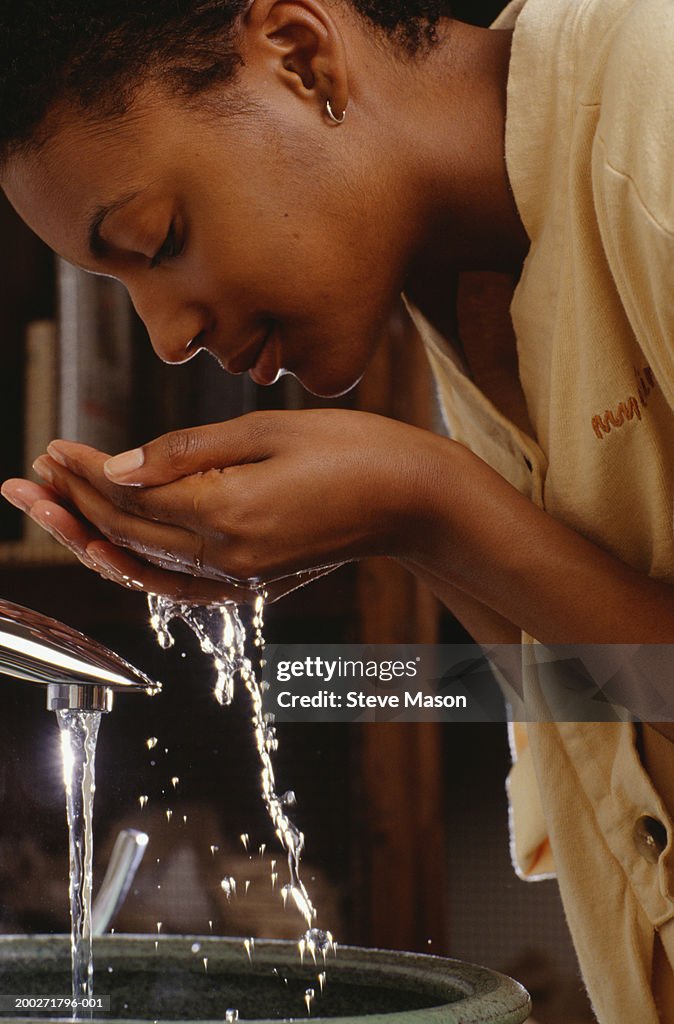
[385,22,529,327]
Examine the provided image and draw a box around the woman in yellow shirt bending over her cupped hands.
[0,0,674,1022]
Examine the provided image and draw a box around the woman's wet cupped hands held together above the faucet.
[2,410,437,603]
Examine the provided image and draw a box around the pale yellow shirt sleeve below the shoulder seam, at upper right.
[592,0,674,409]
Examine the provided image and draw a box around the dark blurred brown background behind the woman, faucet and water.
[0,0,593,1024]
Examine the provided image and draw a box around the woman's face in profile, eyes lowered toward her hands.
[2,74,407,395]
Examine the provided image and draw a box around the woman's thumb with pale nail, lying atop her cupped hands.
[103,413,272,486]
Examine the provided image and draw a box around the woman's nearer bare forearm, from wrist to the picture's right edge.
[402,438,674,643]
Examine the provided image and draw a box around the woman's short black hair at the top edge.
[0,0,447,160]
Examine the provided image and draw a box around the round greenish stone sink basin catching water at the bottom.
[0,935,531,1024]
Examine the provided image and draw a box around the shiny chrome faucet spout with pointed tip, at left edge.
[0,599,161,712]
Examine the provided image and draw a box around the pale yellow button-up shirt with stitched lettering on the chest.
[403,0,674,1024]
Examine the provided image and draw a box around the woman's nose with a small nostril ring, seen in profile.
[129,280,207,364]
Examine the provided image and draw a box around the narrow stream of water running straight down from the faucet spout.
[56,711,100,1016]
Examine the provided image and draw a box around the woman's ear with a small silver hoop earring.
[244,0,348,121]
